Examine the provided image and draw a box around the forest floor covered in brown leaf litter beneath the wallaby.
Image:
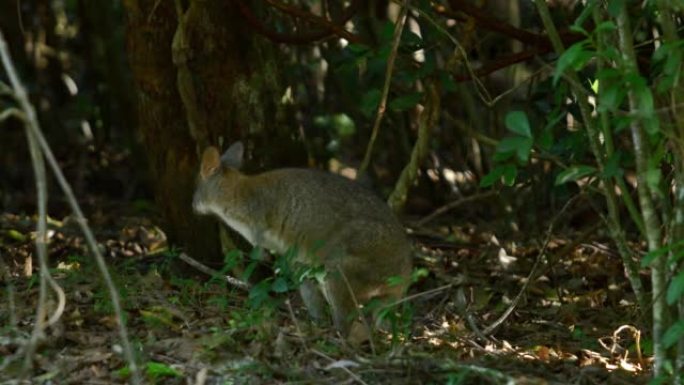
[0,208,650,384]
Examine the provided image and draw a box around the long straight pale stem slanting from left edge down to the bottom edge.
[0,27,142,385]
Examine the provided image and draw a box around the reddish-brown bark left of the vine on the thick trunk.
[124,0,220,262]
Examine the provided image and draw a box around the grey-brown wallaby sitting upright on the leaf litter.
[193,142,411,337]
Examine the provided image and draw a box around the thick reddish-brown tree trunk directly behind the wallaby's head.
[124,0,294,263]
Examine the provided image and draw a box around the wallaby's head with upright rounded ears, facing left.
[192,142,244,214]
